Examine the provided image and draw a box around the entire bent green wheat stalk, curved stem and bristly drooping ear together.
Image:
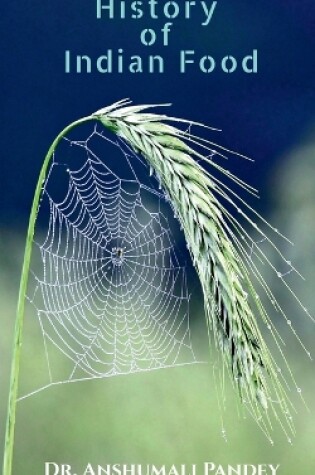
[3,100,312,475]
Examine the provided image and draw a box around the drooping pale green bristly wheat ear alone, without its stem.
[94,101,308,438]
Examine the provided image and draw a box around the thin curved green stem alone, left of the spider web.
[3,116,97,475]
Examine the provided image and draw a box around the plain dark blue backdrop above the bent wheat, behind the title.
[0,0,315,228]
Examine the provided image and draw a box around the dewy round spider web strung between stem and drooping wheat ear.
[24,127,196,398]
